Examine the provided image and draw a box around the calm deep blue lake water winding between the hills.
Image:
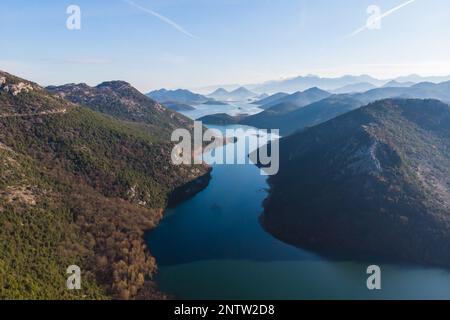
[148,104,450,299]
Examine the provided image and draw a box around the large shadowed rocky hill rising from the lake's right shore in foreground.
[261,97,450,267]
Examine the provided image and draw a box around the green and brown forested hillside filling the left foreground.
[0,72,209,299]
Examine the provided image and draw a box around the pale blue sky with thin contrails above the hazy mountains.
[0,0,450,92]
